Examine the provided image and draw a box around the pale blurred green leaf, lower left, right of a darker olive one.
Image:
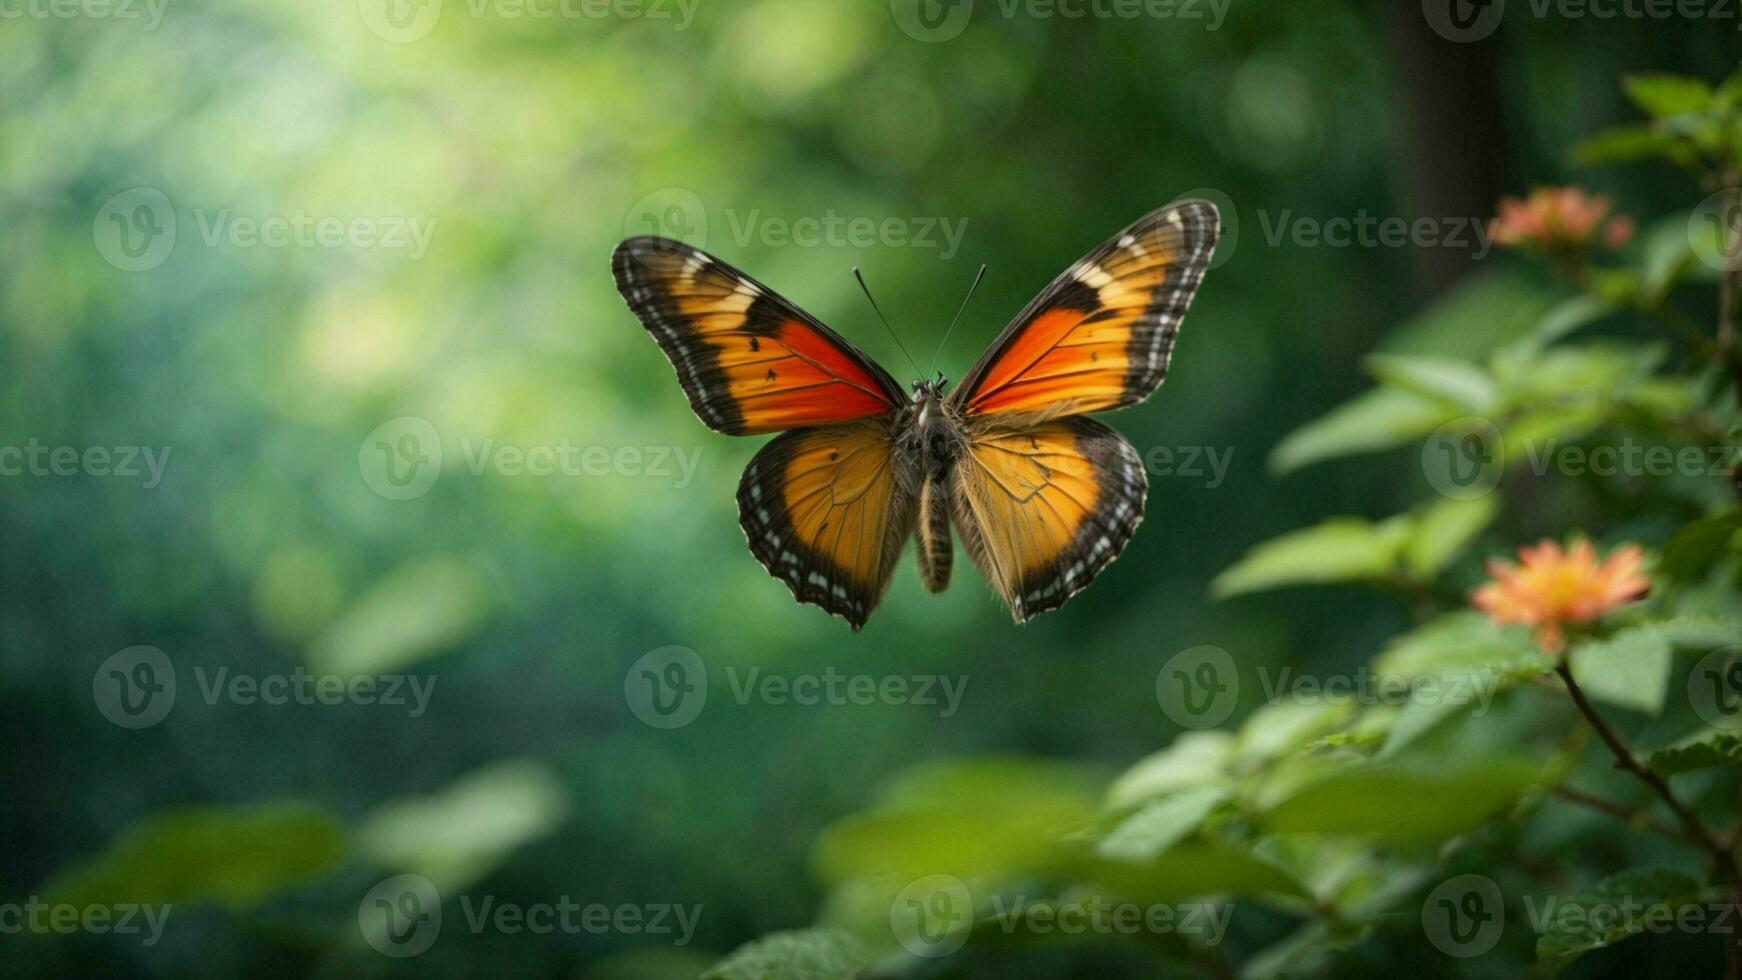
[357,759,568,891]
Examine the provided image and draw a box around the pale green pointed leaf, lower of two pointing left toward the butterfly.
[1209,517,1409,599]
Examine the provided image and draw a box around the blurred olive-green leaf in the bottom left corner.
[44,802,348,909]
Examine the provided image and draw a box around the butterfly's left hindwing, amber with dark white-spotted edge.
[739,416,918,630]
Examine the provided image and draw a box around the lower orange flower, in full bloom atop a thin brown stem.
[1470,538,1651,653]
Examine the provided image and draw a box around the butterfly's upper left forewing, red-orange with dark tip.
[611,237,904,435]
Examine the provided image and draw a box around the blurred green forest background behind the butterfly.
[0,0,1739,977]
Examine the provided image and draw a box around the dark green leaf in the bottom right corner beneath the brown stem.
[1536,869,1704,964]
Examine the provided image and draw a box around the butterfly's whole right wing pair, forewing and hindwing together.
[951,200,1219,621]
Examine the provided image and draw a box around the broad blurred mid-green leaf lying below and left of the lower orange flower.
[1261,757,1538,842]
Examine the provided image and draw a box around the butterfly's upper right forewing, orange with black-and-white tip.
[953,200,1219,414]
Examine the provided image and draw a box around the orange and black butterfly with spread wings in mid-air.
[611,200,1219,630]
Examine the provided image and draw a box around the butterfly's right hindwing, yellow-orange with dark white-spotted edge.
[951,416,1150,623]
